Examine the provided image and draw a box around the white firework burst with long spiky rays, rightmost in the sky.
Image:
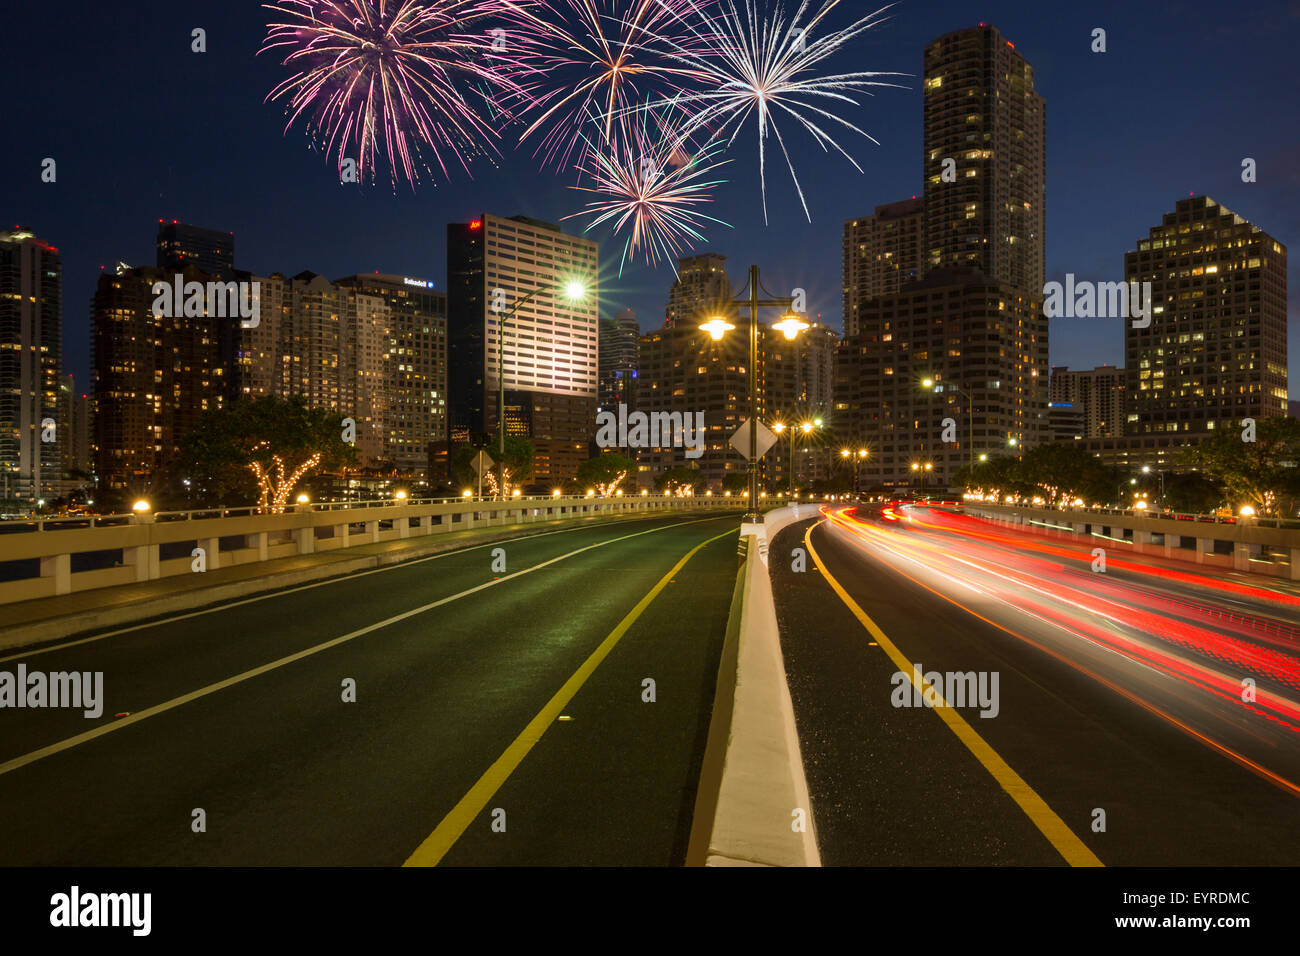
[654,0,905,221]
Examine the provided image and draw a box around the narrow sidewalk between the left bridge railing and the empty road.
[0,511,694,650]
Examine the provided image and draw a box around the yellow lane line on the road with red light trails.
[803,522,1104,866]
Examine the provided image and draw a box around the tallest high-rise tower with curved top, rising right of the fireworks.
[923,25,1047,298]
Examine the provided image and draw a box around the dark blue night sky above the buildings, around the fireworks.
[0,0,1300,390]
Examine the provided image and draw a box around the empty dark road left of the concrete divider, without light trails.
[0,515,738,866]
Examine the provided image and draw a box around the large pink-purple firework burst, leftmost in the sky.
[259,0,508,186]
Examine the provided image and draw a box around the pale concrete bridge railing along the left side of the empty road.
[0,494,736,604]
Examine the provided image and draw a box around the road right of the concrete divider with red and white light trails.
[770,509,1300,866]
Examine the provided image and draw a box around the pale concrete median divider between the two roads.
[686,509,822,866]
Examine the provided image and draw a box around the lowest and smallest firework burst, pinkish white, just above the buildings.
[564,107,731,274]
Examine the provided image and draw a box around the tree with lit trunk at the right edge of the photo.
[1180,418,1300,516]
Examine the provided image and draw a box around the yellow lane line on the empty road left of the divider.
[403,529,736,866]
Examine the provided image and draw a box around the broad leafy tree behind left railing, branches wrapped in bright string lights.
[173,395,356,514]
